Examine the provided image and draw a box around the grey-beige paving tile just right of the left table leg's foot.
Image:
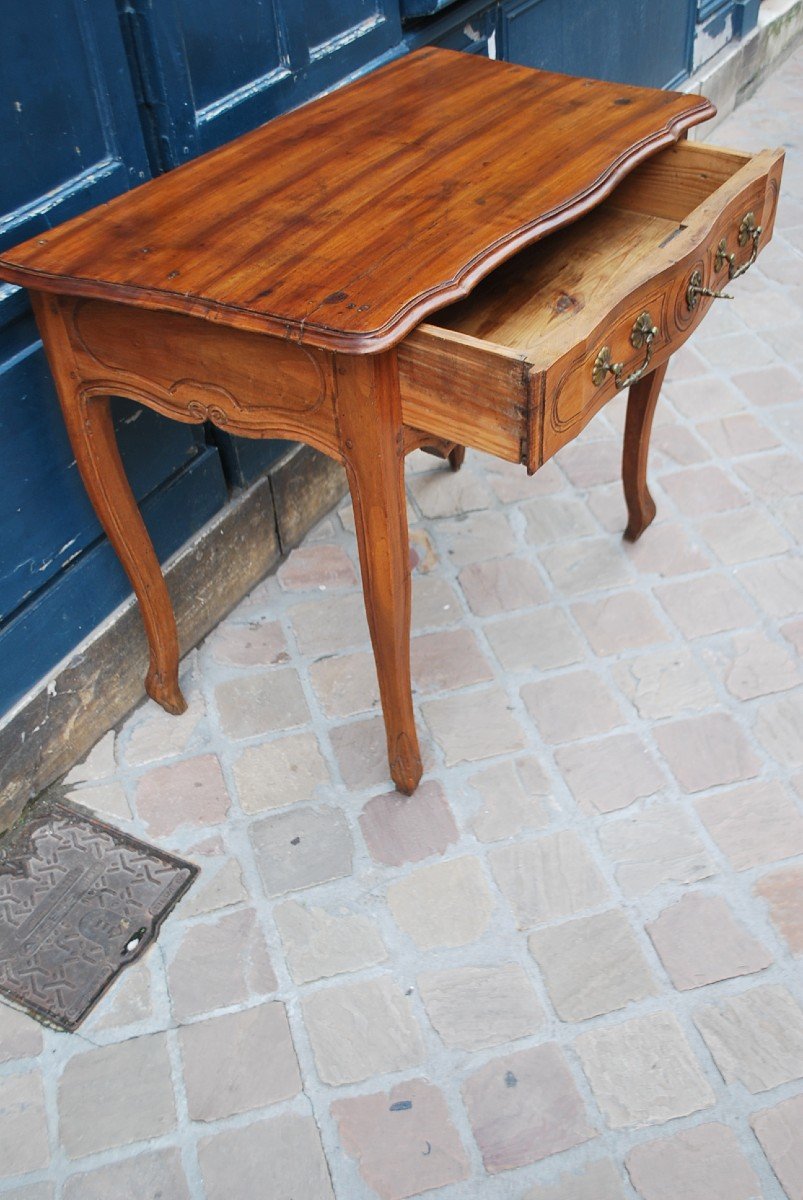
[215,667,310,738]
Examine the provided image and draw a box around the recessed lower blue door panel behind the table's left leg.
[0,317,212,620]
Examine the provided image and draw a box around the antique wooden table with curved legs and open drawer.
[0,49,783,793]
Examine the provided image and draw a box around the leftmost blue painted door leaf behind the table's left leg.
[0,0,227,714]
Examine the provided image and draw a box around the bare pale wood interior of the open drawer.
[429,142,750,354]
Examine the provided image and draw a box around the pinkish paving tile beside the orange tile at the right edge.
[646,892,773,991]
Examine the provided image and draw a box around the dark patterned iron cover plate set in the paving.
[0,803,198,1030]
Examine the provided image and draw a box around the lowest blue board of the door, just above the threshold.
[0,450,226,713]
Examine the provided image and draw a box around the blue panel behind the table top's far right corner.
[499,0,695,88]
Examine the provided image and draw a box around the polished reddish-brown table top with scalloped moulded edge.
[0,48,714,354]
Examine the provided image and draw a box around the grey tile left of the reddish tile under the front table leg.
[248,805,354,896]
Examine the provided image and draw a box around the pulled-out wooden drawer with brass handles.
[398,142,784,472]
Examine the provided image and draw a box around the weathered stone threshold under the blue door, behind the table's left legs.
[0,446,346,833]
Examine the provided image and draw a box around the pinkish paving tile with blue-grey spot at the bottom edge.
[331,1079,471,1200]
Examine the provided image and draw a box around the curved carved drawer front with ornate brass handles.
[528,147,783,469]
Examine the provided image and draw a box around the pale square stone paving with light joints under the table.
[0,42,803,1200]
